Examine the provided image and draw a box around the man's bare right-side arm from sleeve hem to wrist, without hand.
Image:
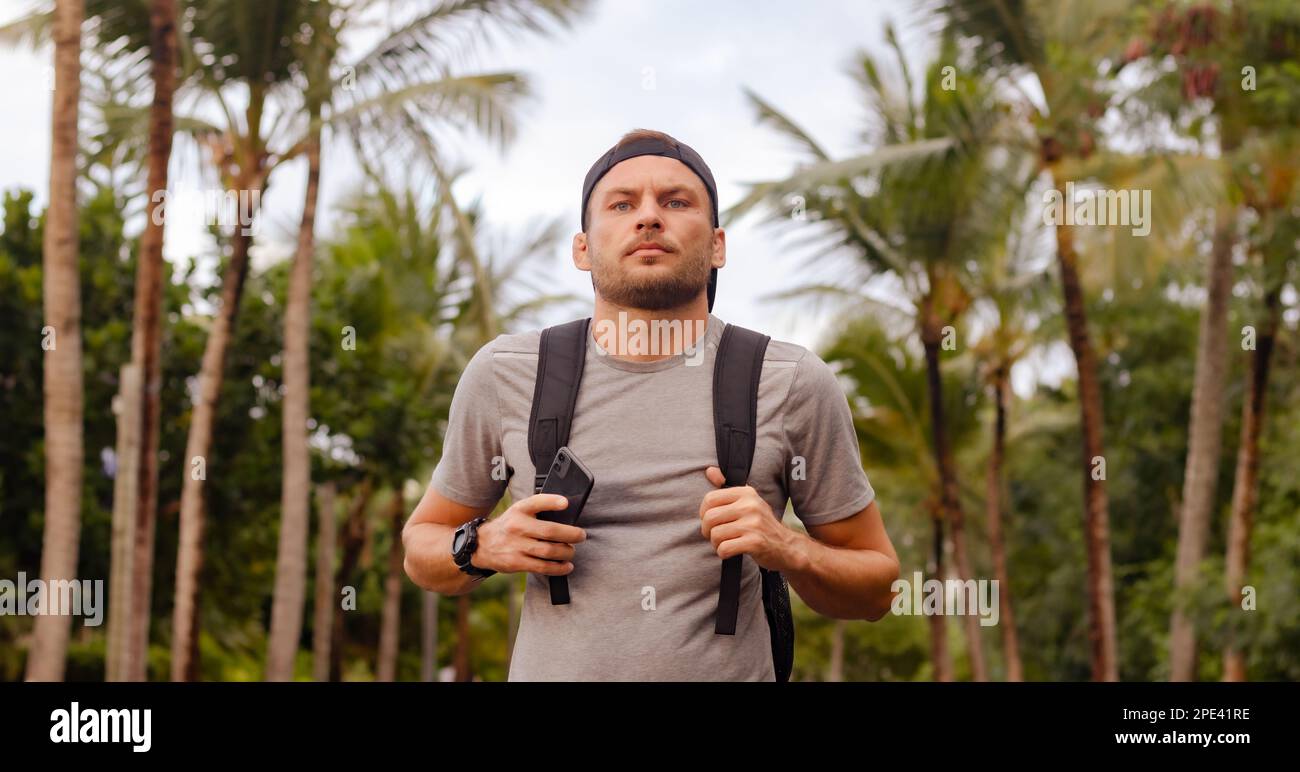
[783,502,900,621]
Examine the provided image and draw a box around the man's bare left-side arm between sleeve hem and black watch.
[402,485,494,595]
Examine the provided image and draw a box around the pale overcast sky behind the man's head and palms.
[0,0,1066,391]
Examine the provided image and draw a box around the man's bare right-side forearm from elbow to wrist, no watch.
[783,532,898,621]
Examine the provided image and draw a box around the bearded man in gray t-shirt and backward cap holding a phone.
[403,130,898,681]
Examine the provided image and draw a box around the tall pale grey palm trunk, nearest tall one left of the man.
[267,109,321,681]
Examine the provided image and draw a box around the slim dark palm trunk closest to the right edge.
[1223,290,1279,681]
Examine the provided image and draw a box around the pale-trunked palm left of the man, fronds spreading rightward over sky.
[267,0,586,680]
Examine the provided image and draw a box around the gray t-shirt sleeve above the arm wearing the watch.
[430,341,508,508]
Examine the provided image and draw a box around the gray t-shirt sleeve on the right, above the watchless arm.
[784,351,876,525]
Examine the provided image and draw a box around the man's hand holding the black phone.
[469,494,586,576]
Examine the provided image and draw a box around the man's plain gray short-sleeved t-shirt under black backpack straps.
[432,313,875,681]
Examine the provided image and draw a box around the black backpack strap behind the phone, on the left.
[528,317,592,606]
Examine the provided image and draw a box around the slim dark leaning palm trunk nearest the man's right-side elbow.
[920,308,988,681]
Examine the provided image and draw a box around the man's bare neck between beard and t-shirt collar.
[592,292,709,361]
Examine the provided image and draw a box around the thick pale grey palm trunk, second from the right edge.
[1169,205,1236,681]
